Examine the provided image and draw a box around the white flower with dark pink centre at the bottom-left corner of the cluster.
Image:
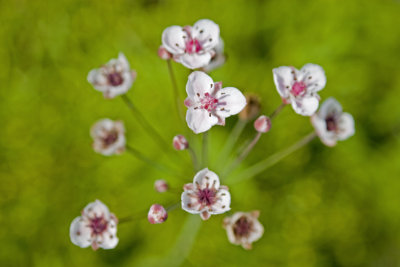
[69,200,118,250]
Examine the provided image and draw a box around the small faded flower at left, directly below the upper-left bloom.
[90,119,126,156]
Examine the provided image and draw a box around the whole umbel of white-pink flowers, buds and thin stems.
[70,19,355,253]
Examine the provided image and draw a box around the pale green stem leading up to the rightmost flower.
[230,132,317,184]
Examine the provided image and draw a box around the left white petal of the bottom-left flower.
[69,216,92,248]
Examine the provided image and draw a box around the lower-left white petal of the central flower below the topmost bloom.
[186,108,218,134]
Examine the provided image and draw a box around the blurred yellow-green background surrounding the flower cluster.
[0,0,400,267]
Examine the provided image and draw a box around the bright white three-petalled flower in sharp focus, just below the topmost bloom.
[185,71,246,133]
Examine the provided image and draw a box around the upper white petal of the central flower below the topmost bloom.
[186,71,214,99]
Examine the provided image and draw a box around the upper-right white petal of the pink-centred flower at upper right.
[298,63,326,93]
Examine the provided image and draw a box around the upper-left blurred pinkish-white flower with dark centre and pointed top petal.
[87,53,136,98]
